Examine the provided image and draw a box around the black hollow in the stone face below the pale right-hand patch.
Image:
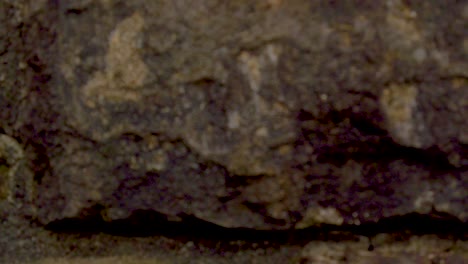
[296,107,460,175]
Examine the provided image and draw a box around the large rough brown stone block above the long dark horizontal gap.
[0,0,468,229]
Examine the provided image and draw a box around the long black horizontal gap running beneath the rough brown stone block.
[45,210,468,252]
